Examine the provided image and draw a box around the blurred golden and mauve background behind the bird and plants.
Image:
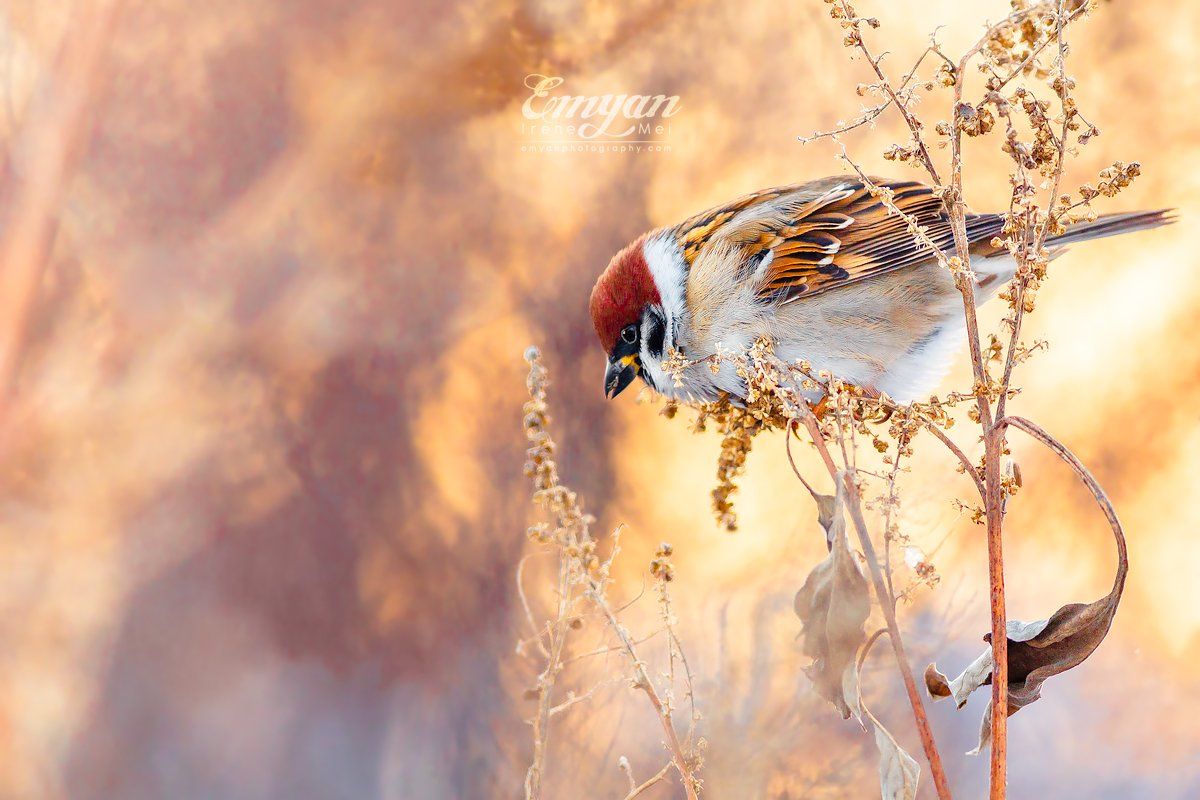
[0,0,1200,800]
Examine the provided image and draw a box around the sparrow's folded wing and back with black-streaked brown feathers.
[677,179,1003,302]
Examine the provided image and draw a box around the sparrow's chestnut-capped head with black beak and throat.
[590,236,667,398]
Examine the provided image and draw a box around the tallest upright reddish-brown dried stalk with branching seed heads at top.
[806,0,1138,800]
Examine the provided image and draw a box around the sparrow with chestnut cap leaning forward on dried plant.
[590,178,1172,402]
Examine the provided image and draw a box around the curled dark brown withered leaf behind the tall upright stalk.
[925,520,1129,756]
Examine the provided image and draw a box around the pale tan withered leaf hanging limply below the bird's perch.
[796,483,871,720]
